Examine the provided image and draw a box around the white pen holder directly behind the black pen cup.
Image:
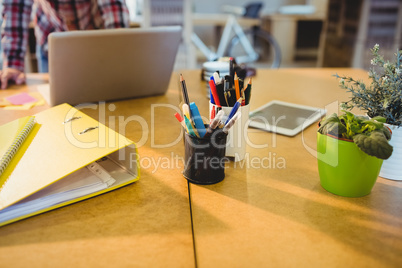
[209,102,250,162]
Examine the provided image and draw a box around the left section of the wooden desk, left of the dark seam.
[0,72,196,267]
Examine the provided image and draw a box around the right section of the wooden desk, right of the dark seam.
[190,69,402,267]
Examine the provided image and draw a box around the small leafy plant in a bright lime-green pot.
[317,111,393,197]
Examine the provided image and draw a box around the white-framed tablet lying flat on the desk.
[249,100,326,136]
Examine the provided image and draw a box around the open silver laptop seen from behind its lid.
[49,26,182,106]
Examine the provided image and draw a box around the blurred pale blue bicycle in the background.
[191,3,281,68]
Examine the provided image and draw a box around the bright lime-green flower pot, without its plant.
[317,133,383,197]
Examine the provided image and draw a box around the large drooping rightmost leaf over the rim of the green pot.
[353,130,393,159]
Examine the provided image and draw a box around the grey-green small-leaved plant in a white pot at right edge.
[335,44,402,180]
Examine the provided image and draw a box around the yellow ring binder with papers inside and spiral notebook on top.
[0,104,140,226]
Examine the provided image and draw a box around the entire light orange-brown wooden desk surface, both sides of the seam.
[0,69,402,267]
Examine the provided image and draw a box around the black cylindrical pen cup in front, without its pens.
[183,129,227,184]
